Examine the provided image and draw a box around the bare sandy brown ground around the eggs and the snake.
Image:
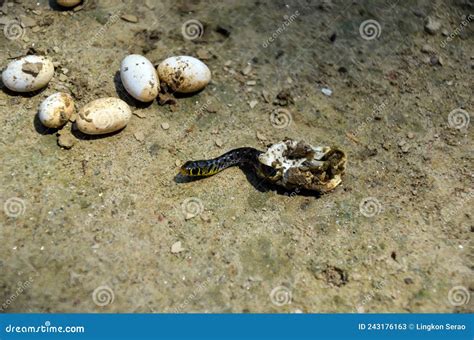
[0,0,474,313]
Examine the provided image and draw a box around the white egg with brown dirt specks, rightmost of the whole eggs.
[158,56,211,93]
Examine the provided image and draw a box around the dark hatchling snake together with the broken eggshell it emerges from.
[181,139,346,193]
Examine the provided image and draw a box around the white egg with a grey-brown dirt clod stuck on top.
[2,55,54,92]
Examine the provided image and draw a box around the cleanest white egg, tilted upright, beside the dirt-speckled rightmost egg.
[120,54,160,102]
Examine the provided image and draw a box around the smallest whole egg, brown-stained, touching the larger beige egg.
[38,92,74,128]
